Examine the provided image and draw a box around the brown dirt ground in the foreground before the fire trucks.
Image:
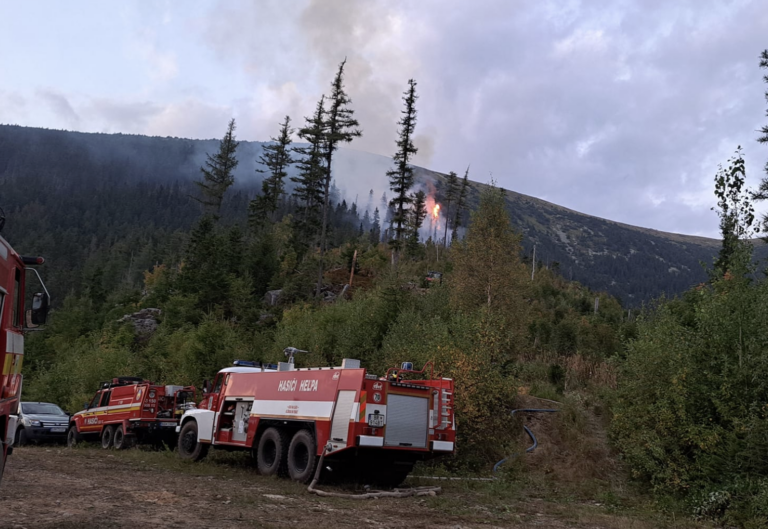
[0,446,700,529]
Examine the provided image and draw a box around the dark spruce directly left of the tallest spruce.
[291,96,325,246]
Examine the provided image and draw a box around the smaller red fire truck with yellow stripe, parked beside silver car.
[67,377,195,450]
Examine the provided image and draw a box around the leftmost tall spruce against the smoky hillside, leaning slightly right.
[192,119,239,220]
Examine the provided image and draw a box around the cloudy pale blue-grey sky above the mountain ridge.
[0,0,768,237]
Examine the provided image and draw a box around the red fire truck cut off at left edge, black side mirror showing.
[0,211,50,480]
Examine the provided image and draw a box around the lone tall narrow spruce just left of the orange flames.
[387,79,418,262]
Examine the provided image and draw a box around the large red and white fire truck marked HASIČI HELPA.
[178,348,456,486]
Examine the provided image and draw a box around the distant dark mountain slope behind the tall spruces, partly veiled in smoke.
[0,125,736,307]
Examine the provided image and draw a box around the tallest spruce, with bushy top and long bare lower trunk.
[316,59,363,297]
